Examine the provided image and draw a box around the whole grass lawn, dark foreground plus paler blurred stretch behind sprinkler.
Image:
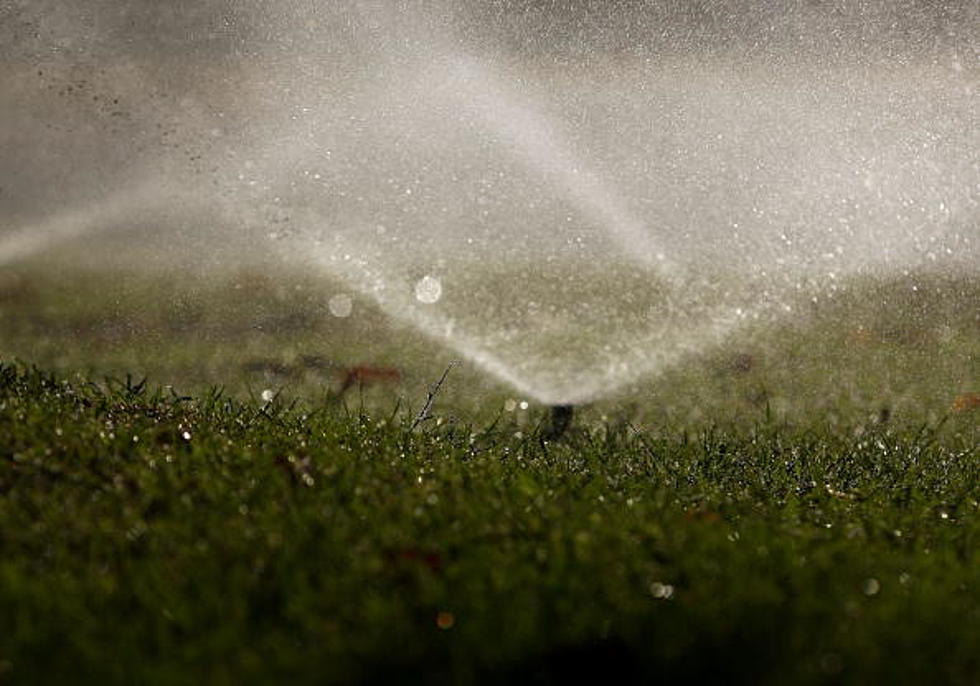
[0,260,980,685]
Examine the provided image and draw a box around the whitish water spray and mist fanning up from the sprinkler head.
[0,2,980,412]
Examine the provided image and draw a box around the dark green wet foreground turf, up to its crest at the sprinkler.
[0,366,980,684]
